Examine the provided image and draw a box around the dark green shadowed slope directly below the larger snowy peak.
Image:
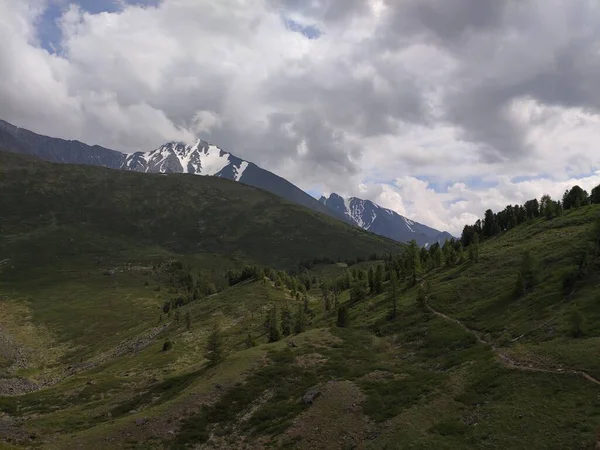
[0,153,400,269]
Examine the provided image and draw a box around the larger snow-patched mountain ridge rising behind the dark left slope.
[0,120,349,223]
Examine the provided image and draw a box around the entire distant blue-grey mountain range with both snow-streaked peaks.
[0,116,451,246]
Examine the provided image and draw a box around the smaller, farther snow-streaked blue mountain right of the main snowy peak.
[319,193,452,247]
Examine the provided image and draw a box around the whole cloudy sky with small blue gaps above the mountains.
[0,0,600,235]
